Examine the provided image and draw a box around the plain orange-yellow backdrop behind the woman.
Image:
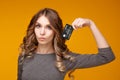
[0,0,120,80]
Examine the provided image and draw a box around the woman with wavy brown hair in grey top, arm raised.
[18,8,115,80]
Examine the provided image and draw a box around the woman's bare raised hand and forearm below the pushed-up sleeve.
[72,18,109,48]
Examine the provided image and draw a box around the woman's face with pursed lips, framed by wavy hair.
[35,15,54,45]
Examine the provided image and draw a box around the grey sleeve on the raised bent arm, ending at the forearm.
[65,47,115,70]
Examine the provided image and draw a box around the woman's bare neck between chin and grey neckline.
[36,44,54,54]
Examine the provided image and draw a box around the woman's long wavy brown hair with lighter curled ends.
[20,8,74,79]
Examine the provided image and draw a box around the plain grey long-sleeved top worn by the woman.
[17,47,115,80]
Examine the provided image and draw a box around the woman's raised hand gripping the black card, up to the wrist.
[72,18,93,29]
